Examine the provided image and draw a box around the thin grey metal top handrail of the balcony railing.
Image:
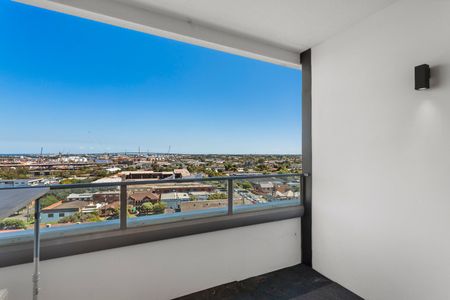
[0,173,309,190]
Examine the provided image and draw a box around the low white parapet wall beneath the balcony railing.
[0,218,301,300]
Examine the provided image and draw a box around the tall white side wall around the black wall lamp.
[312,1,450,300]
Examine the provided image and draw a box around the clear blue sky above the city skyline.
[0,0,301,154]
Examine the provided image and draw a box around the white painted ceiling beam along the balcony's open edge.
[17,0,300,68]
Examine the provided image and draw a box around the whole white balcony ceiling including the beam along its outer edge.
[18,0,396,67]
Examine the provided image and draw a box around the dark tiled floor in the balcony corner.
[178,265,362,300]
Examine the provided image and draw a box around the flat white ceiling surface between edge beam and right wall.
[125,0,395,52]
